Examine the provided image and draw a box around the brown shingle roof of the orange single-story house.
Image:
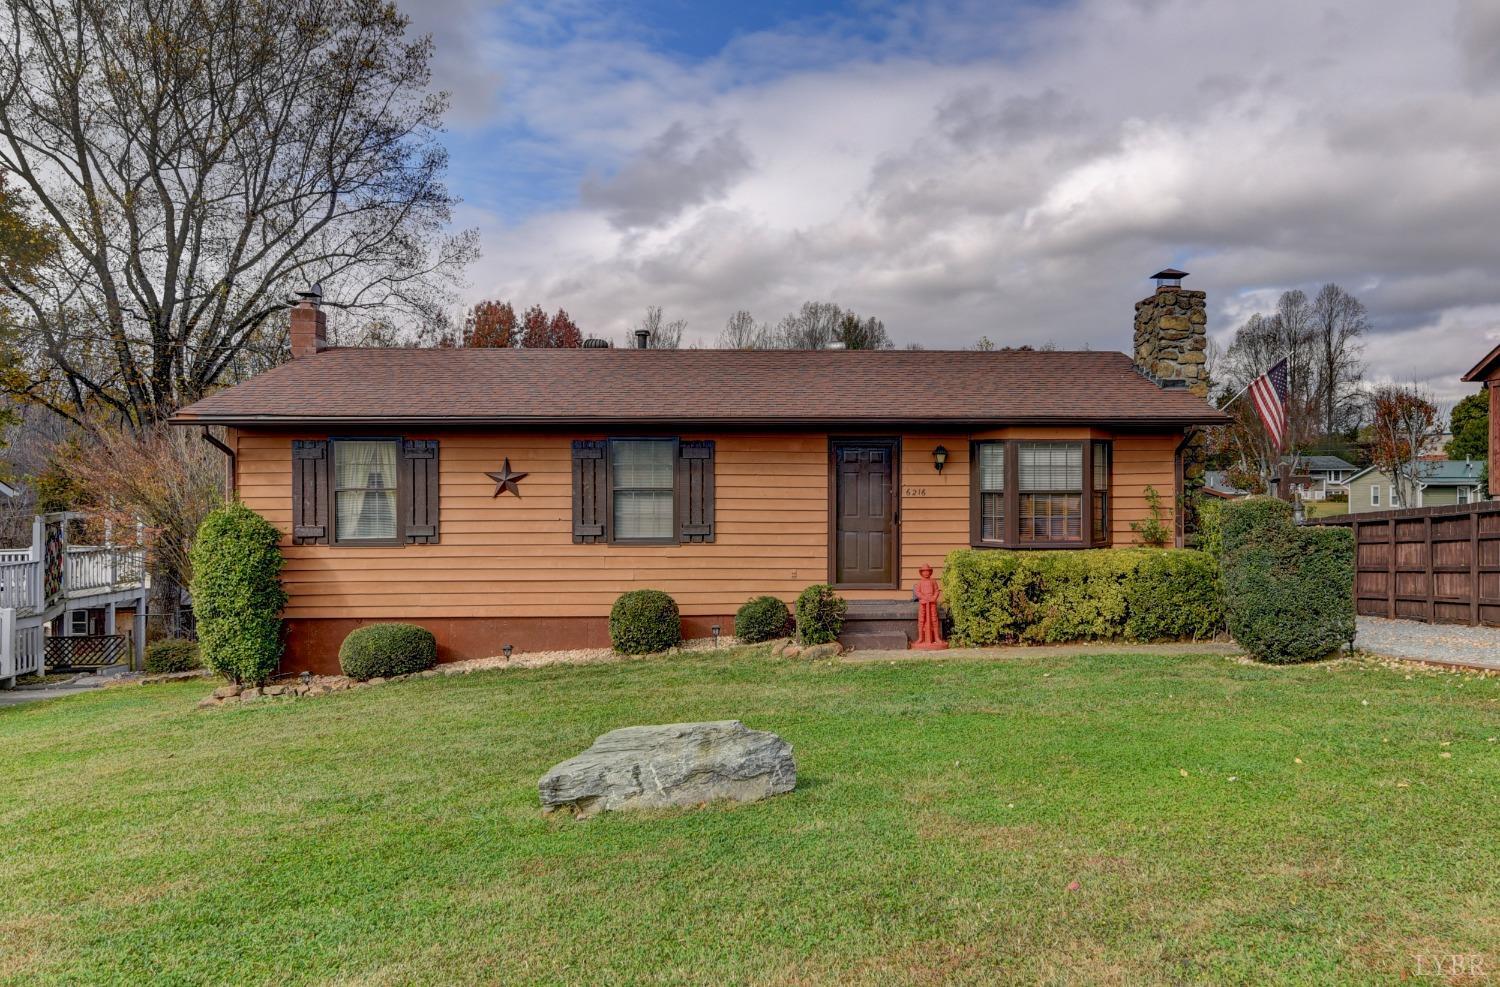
[173,350,1227,426]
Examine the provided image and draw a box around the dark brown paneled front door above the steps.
[831,440,897,587]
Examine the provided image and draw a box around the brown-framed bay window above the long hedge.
[971,441,1112,548]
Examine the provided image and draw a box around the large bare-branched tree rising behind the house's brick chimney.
[0,0,477,428]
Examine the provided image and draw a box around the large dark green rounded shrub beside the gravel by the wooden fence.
[1223,498,1355,665]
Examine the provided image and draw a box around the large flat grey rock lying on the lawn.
[537,720,797,818]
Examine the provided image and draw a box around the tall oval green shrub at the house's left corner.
[191,504,287,686]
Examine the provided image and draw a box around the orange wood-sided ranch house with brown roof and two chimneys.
[173,280,1229,671]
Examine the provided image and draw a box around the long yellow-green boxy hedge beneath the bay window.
[942,549,1224,647]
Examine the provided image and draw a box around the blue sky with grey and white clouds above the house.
[401,0,1500,404]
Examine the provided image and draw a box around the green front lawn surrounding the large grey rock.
[0,651,1500,984]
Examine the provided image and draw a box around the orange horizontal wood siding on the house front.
[231,429,1181,618]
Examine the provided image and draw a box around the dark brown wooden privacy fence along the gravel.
[1308,501,1500,627]
